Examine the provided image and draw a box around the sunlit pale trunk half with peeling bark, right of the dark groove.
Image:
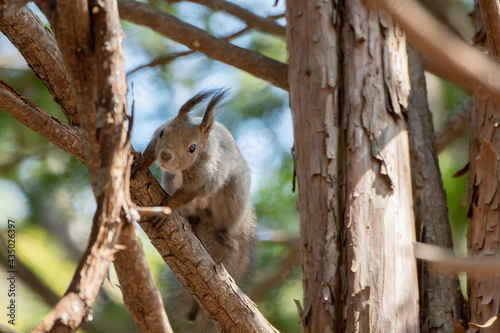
[342,1,419,332]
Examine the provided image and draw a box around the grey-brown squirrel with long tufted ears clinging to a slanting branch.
[136,89,256,332]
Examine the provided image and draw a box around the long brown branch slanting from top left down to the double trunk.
[118,0,288,90]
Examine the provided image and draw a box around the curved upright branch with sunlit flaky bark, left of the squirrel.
[34,0,134,332]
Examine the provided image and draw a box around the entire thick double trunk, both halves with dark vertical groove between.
[287,0,418,332]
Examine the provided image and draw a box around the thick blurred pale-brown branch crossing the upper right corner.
[365,0,500,100]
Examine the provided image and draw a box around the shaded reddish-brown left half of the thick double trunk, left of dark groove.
[286,0,344,333]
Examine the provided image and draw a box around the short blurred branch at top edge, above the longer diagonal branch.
[180,0,286,37]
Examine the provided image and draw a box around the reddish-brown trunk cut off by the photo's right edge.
[467,1,500,333]
